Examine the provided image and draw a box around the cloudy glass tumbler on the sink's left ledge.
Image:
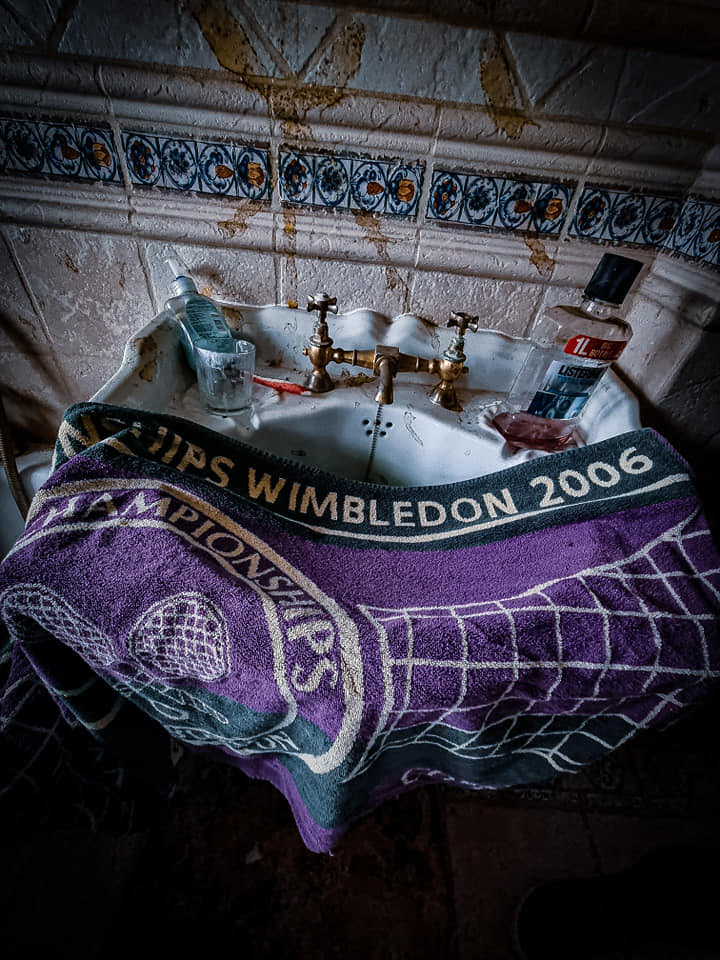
[195,340,255,414]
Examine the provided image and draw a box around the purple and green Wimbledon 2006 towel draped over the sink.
[0,404,720,851]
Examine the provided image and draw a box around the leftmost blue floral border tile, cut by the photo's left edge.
[0,117,121,183]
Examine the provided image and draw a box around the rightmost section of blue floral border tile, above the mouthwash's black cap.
[568,186,720,266]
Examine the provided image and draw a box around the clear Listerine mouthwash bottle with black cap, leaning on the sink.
[493,253,642,452]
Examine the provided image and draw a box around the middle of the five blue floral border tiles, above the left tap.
[279,151,425,217]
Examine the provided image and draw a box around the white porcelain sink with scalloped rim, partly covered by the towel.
[92,301,640,486]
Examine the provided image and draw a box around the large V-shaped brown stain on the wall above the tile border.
[189,0,365,140]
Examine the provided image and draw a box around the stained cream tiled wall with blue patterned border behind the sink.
[0,0,720,466]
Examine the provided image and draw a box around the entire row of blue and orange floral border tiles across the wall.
[0,117,720,268]
